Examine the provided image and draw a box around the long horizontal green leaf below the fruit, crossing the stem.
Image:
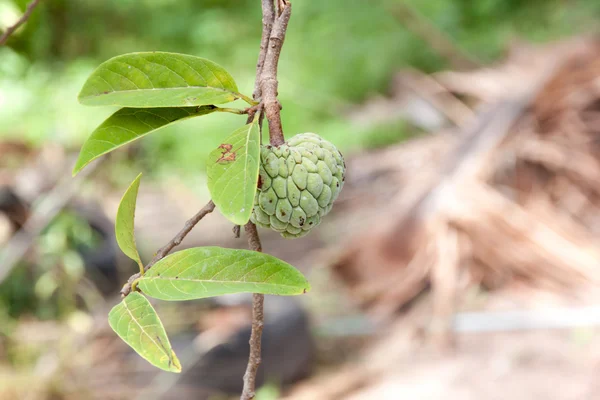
[137,247,310,300]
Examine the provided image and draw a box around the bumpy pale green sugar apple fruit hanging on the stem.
[250,133,346,238]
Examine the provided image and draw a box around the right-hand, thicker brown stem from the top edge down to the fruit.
[260,1,292,146]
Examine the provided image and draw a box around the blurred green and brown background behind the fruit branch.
[0,0,600,400]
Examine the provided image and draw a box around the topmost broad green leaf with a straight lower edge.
[78,51,242,108]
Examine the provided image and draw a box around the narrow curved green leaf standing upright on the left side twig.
[115,174,144,271]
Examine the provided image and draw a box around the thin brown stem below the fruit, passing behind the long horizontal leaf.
[240,222,265,400]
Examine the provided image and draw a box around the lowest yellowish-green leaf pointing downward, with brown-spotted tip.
[108,292,181,372]
